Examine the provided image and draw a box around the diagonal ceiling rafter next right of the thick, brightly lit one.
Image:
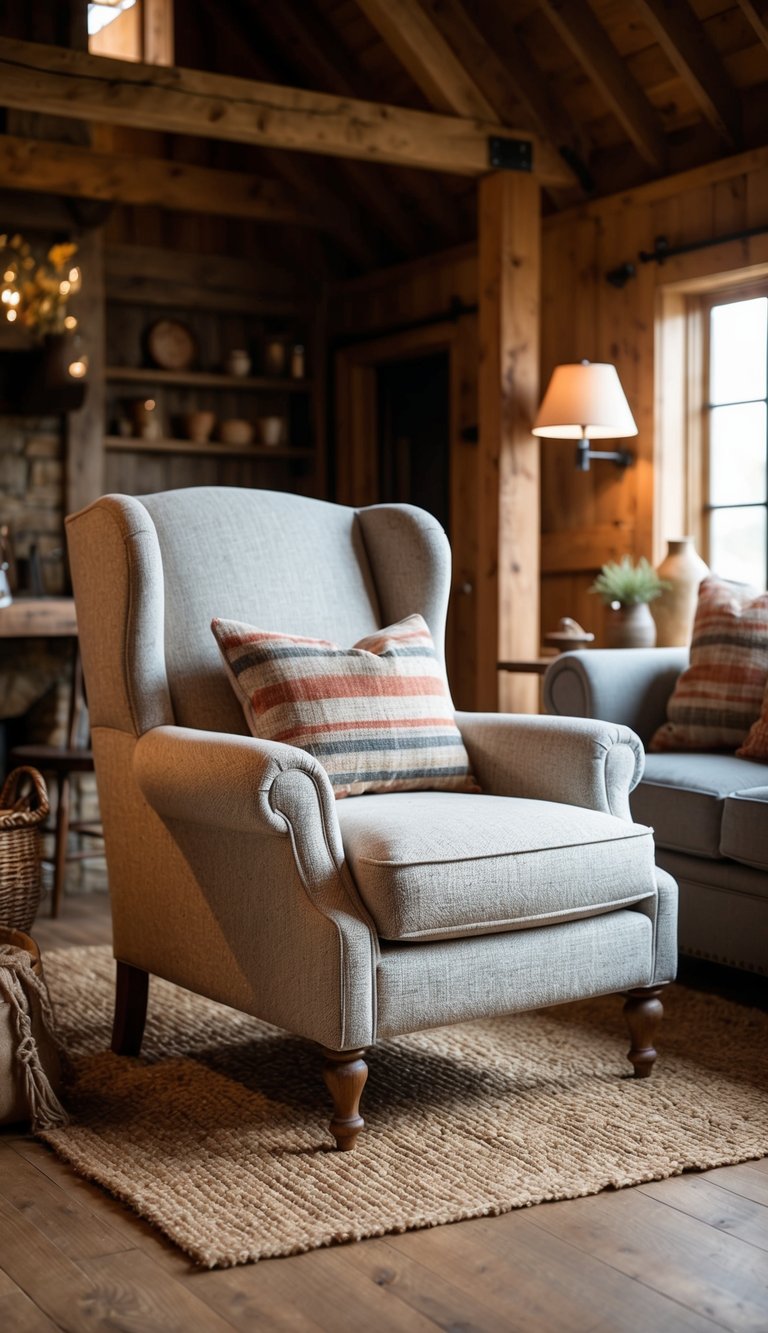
[539,0,667,172]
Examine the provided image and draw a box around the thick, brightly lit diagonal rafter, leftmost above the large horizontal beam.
[357,0,497,120]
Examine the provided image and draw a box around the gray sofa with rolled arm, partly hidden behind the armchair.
[544,648,768,976]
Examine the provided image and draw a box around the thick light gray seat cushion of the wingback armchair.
[337,792,656,940]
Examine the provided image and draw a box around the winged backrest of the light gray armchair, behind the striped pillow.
[67,487,451,736]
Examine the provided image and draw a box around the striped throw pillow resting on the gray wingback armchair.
[211,616,479,797]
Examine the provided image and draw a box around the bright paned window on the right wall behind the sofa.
[703,292,768,588]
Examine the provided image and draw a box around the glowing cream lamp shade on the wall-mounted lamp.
[532,361,637,440]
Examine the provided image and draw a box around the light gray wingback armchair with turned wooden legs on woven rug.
[67,488,676,1148]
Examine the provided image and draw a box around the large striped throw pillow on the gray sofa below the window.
[648,576,768,750]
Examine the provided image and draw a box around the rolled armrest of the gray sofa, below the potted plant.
[544,648,688,744]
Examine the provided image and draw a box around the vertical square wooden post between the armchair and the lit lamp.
[476,172,540,712]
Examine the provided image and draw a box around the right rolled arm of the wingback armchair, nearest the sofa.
[456,713,644,820]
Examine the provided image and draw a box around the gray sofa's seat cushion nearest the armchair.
[629,754,768,860]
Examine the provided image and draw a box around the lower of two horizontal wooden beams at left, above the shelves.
[0,135,324,231]
